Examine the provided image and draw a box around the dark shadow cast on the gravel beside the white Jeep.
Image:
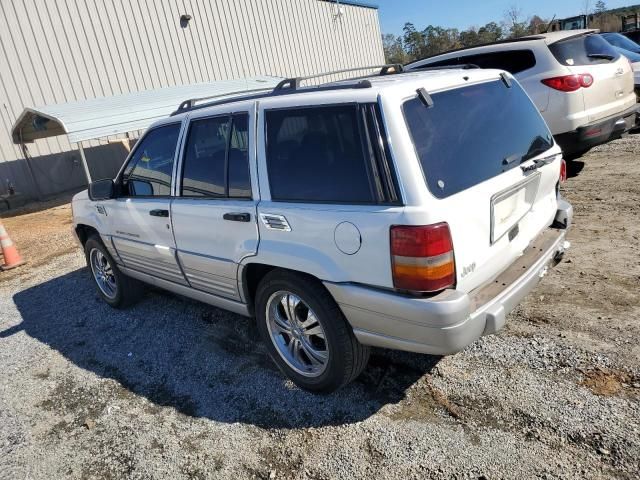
[0,269,439,428]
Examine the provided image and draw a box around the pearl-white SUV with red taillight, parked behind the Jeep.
[405,30,640,159]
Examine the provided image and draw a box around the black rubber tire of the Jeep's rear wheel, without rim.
[255,270,370,393]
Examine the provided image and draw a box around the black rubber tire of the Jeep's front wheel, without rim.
[84,235,144,308]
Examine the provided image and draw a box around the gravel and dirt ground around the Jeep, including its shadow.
[0,135,640,479]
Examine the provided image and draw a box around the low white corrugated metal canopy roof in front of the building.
[12,76,282,143]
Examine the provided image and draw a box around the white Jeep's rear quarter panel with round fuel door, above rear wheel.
[249,201,404,288]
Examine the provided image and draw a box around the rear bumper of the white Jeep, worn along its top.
[325,202,572,355]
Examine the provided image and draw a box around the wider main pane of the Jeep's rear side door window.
[181,117,229,197]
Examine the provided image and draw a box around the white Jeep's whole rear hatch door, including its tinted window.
[403,76,561,291]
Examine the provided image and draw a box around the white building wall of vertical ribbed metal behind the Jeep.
[0,0,384,197]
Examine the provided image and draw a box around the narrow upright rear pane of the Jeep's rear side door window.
[229,115,251,198]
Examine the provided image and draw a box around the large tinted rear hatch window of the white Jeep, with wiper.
[403,81,553,198]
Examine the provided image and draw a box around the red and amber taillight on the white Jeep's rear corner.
[391,222,456,292]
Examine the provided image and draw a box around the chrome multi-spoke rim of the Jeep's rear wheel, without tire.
[266,291,329,377]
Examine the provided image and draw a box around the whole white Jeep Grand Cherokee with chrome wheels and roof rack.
[73,69,572,392]
